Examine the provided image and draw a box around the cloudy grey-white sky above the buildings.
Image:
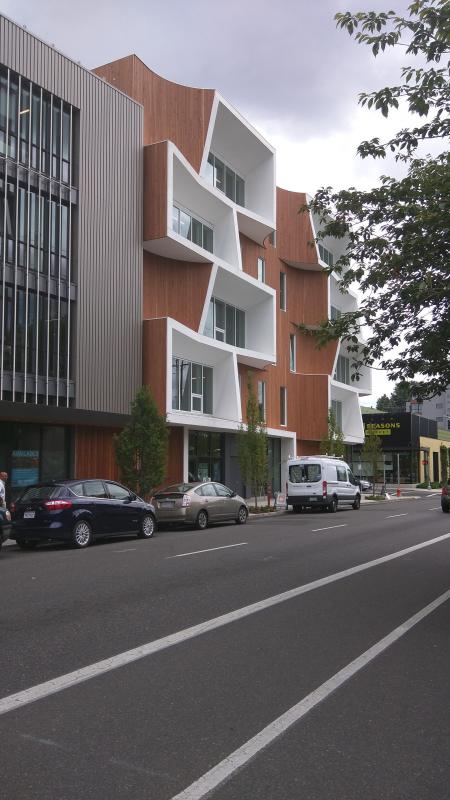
[4,0,418,402]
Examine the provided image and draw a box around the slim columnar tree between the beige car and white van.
[237,376,269,508]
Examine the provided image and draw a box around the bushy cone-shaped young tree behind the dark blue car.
[115,386,169,497]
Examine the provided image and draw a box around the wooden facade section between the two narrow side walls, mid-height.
[143,252,212,331]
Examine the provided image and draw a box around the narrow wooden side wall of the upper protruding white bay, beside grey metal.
[143,142,167,242]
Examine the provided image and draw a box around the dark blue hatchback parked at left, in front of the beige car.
[11,478,156,549]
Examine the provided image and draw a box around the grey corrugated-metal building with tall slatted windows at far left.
[0,16,142,492]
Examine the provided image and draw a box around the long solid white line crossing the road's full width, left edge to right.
[0,533,450,716]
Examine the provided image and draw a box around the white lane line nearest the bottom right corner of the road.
[167,590,450,800]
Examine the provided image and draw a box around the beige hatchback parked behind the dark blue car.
[153,481,248,530]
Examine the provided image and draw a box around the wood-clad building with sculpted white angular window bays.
[96,56,371,491]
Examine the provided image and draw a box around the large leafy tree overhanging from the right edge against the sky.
[300,0,450,397]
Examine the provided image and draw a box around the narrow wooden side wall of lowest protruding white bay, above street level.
[142,318,167,414]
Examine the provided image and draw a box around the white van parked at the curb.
[286,456,361,512]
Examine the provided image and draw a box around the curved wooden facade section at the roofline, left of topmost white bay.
[94,55,214,172]
